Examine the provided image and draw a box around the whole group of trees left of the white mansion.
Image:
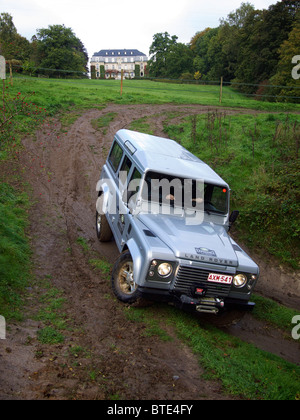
[0,13,88,77]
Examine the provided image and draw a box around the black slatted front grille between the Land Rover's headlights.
[173,265,231,297]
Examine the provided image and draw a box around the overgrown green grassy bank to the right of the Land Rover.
[165,111,300,269]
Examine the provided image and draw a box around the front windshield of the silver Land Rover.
[142,171,228,215]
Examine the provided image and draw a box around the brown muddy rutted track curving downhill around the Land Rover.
[0,105,300,400]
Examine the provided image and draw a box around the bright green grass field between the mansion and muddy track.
[6,77,300,114]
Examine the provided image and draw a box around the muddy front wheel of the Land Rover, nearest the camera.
[112,251,139,303]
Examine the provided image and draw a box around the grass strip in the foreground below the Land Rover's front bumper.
[125,305,300,400]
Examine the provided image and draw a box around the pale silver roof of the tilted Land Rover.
[116,129,228,187]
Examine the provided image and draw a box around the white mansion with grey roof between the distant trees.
[91,50,148,79]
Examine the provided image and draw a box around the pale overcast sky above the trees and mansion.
[0,0,277,57]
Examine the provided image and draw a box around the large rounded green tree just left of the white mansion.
[36,25,88,77]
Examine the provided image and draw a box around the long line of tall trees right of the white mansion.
[148,0,300,97]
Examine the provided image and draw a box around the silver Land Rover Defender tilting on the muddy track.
[96,130,259,314]
